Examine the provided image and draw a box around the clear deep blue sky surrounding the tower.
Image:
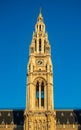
[0,0,81,109]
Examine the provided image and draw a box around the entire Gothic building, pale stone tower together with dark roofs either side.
[0,9,81,130]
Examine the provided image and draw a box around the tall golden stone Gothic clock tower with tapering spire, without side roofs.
[24,11,56,130]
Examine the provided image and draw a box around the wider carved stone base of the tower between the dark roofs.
[24,111,56,130]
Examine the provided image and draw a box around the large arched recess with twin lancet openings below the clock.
[33,77,47,109]
